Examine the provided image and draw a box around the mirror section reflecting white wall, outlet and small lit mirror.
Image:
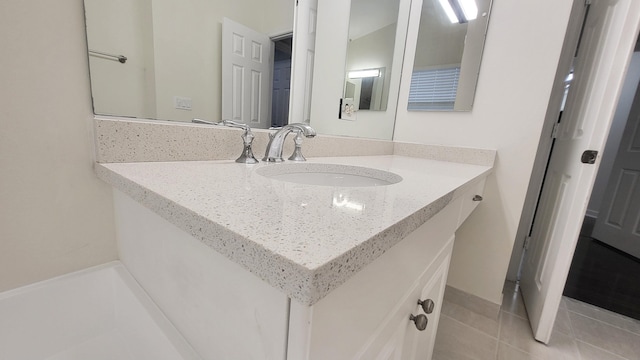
[310,0,410,140]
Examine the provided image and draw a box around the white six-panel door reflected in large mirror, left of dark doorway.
[222,18,272,129]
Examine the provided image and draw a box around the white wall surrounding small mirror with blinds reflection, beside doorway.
[394,0,572,303]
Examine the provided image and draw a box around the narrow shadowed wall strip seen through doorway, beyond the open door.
[587,52,640,218]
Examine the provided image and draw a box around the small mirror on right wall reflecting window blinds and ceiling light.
[407,0,491,111]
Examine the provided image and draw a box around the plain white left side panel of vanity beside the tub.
[114,190,289,360]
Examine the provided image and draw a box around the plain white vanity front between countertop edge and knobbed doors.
[300,199,462,360]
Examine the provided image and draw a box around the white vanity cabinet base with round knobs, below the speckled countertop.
[115,183,484,360]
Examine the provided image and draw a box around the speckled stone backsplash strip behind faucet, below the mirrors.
[94,116,496,166]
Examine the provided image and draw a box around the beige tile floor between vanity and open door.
[433,283,640,360]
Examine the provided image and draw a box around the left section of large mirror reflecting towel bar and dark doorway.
[85,0,294,127]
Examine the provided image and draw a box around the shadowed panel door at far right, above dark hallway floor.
[593,80,640,258]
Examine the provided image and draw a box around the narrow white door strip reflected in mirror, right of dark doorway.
[289,0,318,123]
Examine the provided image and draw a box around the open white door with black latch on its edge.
[521,0,640,343]
